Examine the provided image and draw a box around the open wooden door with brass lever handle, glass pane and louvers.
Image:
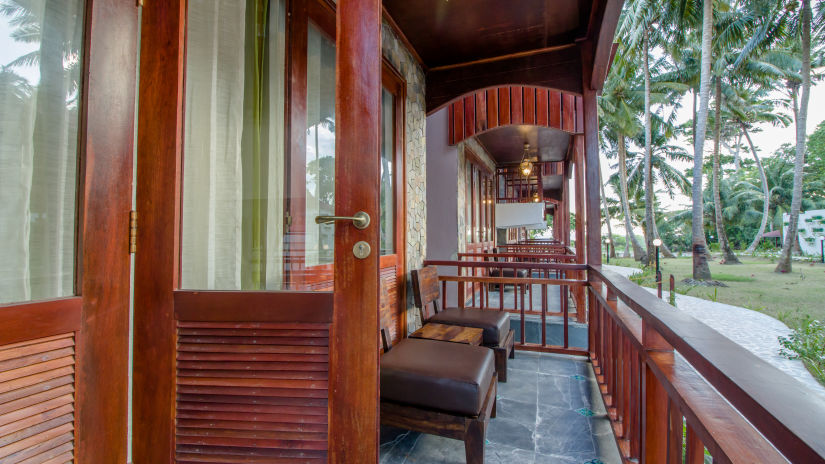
[133,0,381,463]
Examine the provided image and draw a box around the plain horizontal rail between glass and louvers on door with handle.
[174,290,332,323]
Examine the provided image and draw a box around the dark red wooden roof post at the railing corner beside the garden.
[584,89,602,265]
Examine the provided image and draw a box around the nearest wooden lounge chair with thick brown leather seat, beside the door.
[380,329,496,464]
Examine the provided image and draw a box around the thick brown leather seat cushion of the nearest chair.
[381,338,495,416]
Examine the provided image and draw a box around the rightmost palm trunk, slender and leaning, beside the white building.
[775,0,811,272]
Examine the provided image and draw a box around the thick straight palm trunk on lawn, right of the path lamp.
[691,0,713,280]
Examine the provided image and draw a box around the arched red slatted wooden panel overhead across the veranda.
[447,85,584,145]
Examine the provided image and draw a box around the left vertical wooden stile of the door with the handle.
[132,0,186,463]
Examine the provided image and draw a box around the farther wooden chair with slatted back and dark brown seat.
[412,266,515,382]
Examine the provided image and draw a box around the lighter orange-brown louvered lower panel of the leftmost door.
[0,333,75,464]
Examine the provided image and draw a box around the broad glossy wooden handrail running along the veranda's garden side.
[590,266,825,463]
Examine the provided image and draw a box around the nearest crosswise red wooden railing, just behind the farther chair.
[424,256,587,356]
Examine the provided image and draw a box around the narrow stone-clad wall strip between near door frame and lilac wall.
[381,22,427,331]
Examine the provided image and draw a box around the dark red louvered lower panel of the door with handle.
[175,322,329,463]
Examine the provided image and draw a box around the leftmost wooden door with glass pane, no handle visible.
[0,0,137,463]
